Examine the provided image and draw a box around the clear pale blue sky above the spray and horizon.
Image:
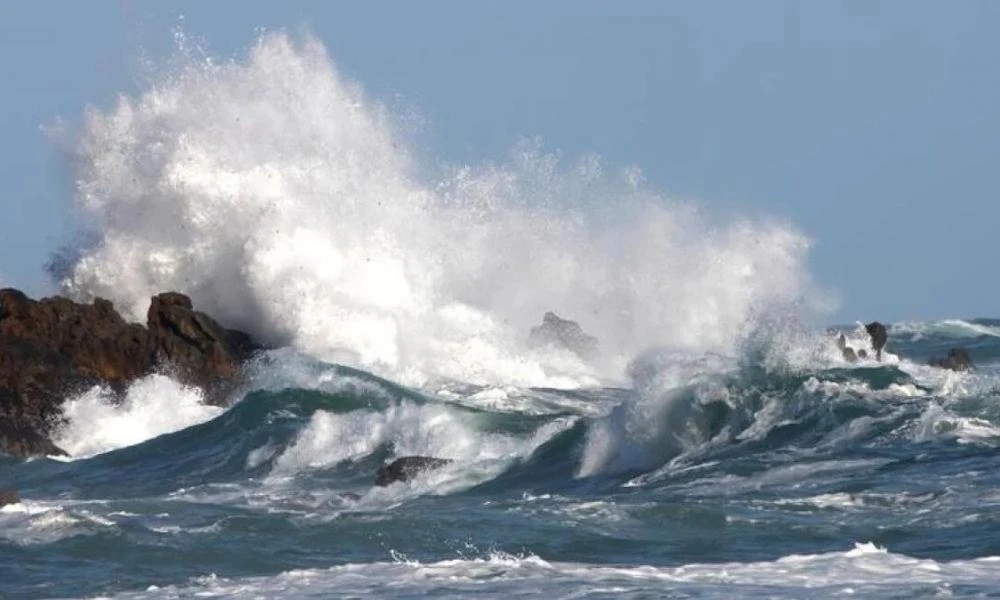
[0,0,1000,322]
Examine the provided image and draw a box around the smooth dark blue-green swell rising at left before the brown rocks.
[6,367,569,499]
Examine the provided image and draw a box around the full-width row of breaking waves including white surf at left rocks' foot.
[25,350,1000,504]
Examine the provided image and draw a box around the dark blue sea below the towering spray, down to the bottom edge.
[0,321,1000,598]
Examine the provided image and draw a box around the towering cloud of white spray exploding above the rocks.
[52,33,825,388]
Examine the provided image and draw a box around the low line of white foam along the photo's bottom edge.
[88,543,1000,599]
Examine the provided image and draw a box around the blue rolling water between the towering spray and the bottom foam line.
[0,354,1000,595]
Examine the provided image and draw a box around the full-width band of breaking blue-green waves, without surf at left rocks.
[4,346,1000,506]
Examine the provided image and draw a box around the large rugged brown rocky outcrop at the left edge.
[0,289,258,456]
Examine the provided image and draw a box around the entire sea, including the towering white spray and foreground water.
[0,33,1000,598]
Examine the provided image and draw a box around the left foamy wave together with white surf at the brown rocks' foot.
[26,352,579,497]
